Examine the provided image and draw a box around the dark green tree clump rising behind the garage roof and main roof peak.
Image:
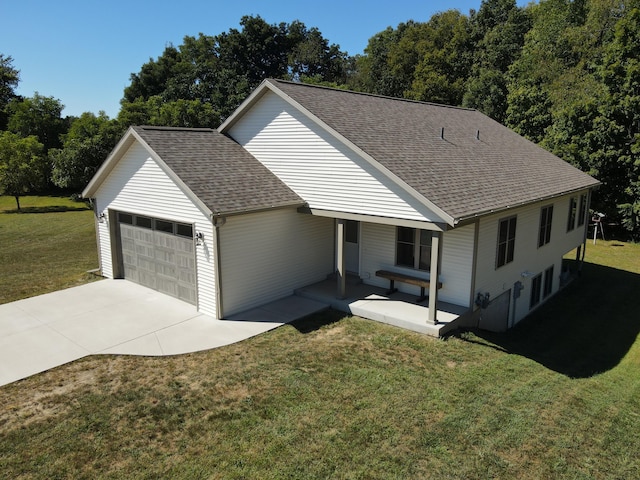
[118,16,346,127]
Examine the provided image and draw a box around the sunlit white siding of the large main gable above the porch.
[229,92,441,222]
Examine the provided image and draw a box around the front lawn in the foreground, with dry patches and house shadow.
[0,197,640,479]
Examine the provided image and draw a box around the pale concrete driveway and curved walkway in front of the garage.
[0,280,327,385]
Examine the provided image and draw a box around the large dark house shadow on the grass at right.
[458,263,640,378]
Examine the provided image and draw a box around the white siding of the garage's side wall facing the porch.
[220,208,334,317]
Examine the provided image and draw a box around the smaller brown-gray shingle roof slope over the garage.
[132,126,304,214]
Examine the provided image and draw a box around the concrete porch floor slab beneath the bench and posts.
[295,275,471,337]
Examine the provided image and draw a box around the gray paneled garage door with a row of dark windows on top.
[118,212,197,305]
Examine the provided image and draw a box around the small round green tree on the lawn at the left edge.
[0,132,46,210]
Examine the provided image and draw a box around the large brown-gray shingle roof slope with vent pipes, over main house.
[268,80,599,220]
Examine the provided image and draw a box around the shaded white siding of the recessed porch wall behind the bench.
[361,223,474,306]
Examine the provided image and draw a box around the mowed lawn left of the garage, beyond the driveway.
[0,196,98,303]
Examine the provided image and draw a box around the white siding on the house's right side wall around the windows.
[475,194,584,325]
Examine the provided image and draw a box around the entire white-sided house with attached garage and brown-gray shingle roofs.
[83,80,599,335]
